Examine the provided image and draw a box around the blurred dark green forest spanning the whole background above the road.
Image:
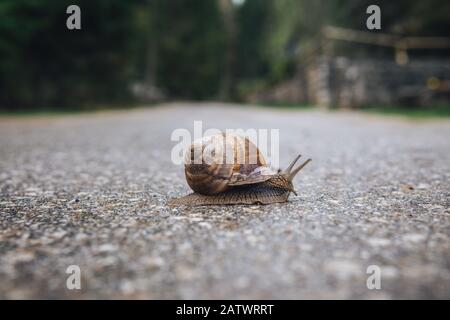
[0,0,450,110]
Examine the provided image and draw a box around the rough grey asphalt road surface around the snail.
[0,103,450,299]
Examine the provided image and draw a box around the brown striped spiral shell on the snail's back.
[185,133,276,195]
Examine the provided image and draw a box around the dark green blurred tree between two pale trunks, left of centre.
[150,0,227,99]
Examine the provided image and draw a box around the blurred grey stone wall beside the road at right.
[253,57,450,108]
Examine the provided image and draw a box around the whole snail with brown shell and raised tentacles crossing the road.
[170,133,311,206]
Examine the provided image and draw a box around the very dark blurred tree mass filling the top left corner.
[0,0,141,109]
